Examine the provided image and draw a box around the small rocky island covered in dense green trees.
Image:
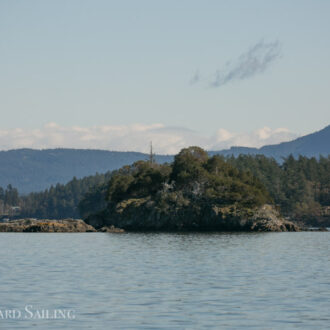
[85,147,300,231]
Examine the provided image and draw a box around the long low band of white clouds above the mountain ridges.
[0,123,297,154]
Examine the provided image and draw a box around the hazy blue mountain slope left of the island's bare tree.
[0,149,172,194]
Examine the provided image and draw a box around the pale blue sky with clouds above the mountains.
[0,0,330,153]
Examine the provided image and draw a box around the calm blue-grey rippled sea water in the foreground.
[0,232,330,329]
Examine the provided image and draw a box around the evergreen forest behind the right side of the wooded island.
[227,155,330,220]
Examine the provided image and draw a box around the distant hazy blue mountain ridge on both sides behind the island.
[0,125,330,194]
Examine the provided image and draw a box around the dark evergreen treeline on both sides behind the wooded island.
[0,155,330,220]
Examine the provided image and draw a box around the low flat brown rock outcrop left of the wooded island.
[0,219,96,233]
